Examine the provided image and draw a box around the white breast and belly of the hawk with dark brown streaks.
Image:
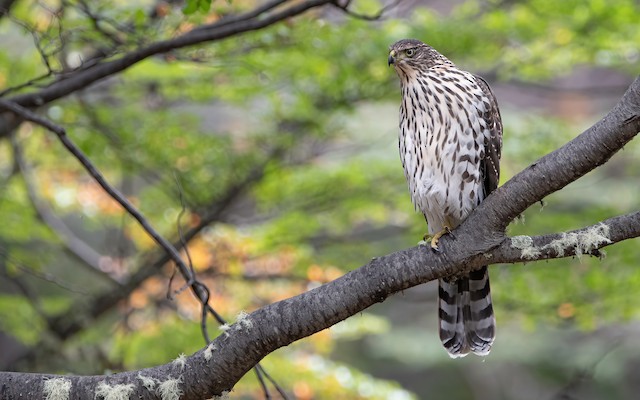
[399,67,490,233]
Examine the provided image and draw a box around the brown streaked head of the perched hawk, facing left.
[388,39,453,73]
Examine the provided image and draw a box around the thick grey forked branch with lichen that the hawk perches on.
[0,70,640,400]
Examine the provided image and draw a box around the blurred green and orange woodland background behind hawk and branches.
[0,0,640,400]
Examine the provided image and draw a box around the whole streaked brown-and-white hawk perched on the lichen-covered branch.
[388,39,502,358]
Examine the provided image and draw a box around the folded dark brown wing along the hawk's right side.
[474,75,502,197]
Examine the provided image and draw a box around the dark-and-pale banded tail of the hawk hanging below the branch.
[438,267,496,358]
